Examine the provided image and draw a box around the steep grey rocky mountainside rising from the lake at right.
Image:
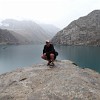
[52,10,100,46]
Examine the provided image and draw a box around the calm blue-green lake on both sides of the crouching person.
[0,45,100,74]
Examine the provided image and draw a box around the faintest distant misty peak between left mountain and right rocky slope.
[39,24,60,38]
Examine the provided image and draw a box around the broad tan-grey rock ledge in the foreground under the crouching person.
[0,60,100,100]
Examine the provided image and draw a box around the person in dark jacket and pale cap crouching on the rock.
[42,40,56,66]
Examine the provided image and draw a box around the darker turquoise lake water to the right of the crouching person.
[57,46,100,72]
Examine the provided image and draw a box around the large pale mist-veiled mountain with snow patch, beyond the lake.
[0,19,57,44]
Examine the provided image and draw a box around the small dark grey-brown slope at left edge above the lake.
[0,29,25,44]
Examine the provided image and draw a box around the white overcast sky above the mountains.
[0,0,100,29]
